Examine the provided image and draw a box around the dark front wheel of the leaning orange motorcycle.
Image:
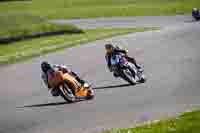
[59,82,76,103]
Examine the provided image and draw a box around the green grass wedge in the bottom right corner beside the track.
[104,111,200,133]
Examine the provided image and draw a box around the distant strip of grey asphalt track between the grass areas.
[50,15,193,29]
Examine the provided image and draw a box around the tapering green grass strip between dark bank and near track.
[0,28,158,64]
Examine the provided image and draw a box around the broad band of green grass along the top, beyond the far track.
[0,0,200,19]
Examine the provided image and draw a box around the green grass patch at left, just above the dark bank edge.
[0,13,81,38]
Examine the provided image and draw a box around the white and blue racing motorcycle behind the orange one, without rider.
[111,55,146,84]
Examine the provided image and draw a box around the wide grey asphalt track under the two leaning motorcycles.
[0,17,200,133]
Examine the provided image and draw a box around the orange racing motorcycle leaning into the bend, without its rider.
[48,71,94,103]
